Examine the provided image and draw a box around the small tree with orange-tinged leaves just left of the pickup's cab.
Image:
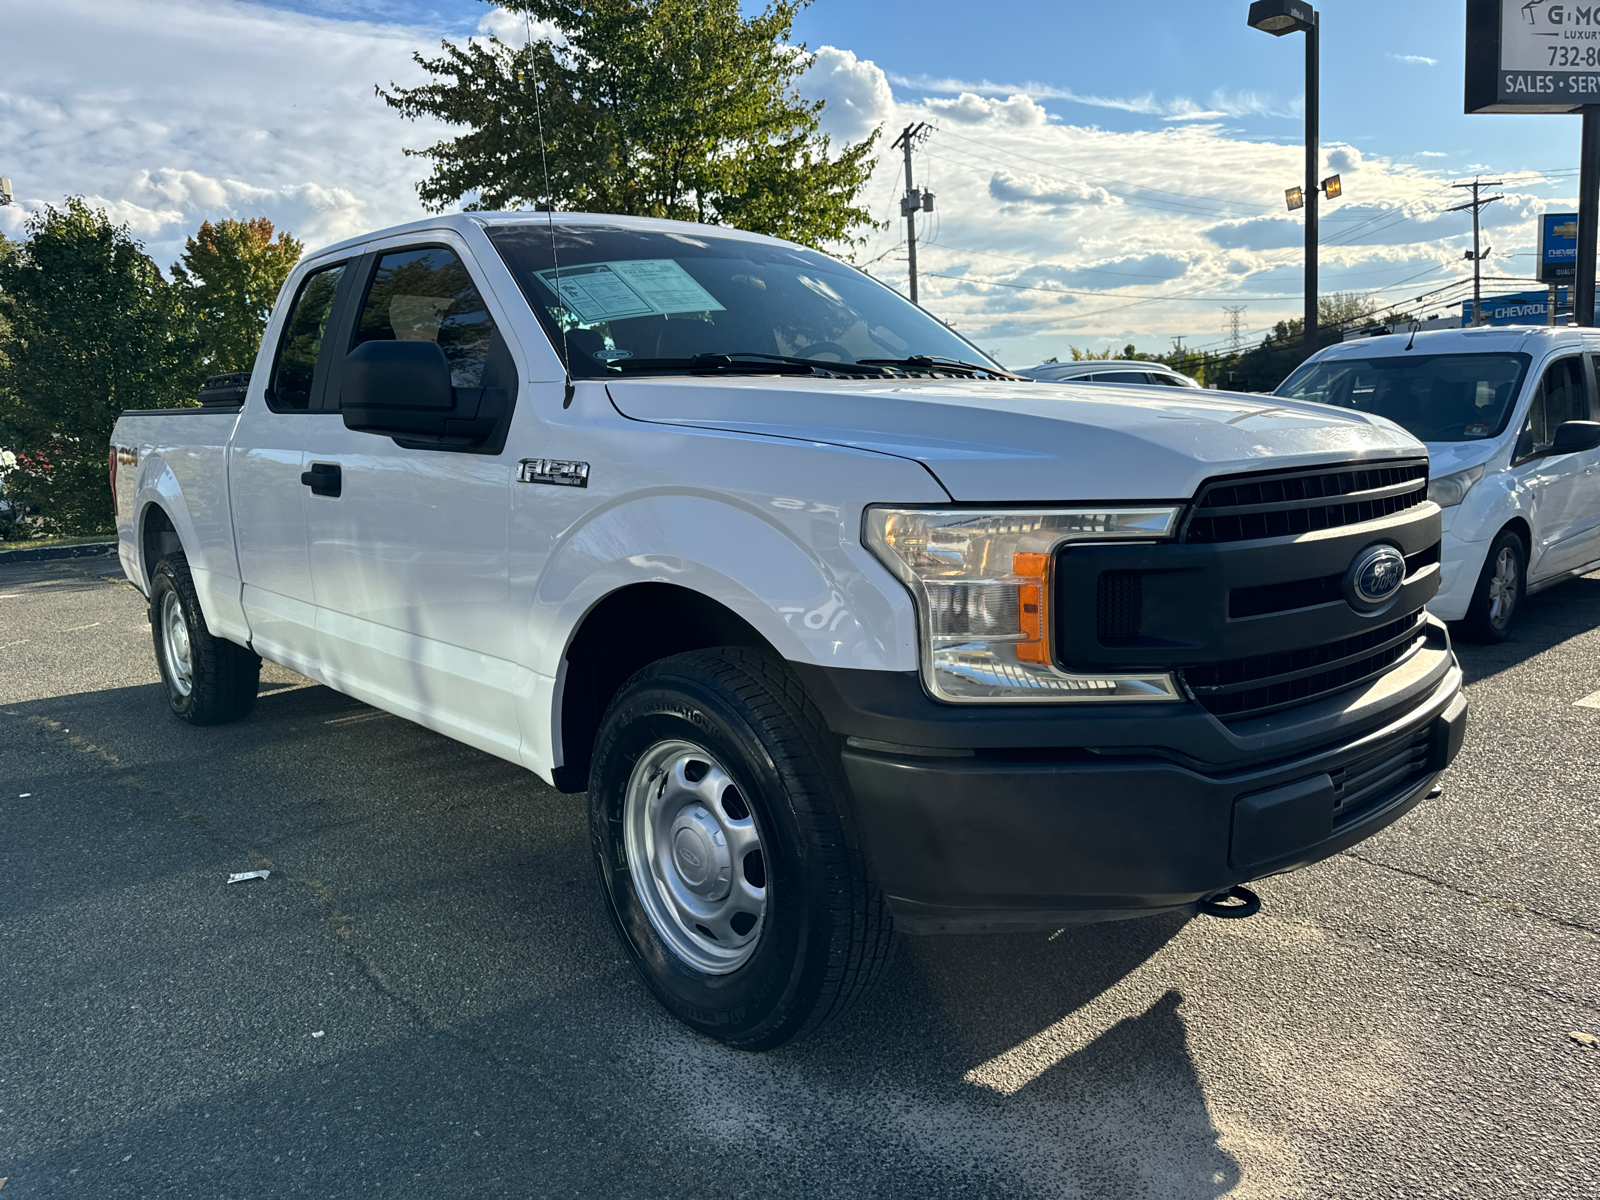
[173,216,304,382]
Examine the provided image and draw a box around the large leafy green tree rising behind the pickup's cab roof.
[378,0,878,245]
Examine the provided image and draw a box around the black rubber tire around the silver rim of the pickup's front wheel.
[589,648,894,1050]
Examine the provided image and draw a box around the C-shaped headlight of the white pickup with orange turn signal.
[866,507,1182,704]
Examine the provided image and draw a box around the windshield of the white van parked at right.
[1274,354,1528,442]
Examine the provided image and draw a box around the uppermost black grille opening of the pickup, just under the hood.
[1182,459,1427,542]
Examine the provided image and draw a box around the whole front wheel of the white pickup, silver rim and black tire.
[589,648,893,1050]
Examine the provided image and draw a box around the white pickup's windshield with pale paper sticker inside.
[488,224,994,379]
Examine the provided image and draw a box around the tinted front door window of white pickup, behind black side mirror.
[352,246,494,387]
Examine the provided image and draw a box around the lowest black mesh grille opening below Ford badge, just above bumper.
[1182,610,1426,720]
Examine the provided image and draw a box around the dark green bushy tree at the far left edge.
[0,197,194,533]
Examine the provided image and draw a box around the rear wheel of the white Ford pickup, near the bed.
[150,554,261,725]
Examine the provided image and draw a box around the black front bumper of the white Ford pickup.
[793,630,1467,933]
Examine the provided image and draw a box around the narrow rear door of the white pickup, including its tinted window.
[229,262,354,680]
